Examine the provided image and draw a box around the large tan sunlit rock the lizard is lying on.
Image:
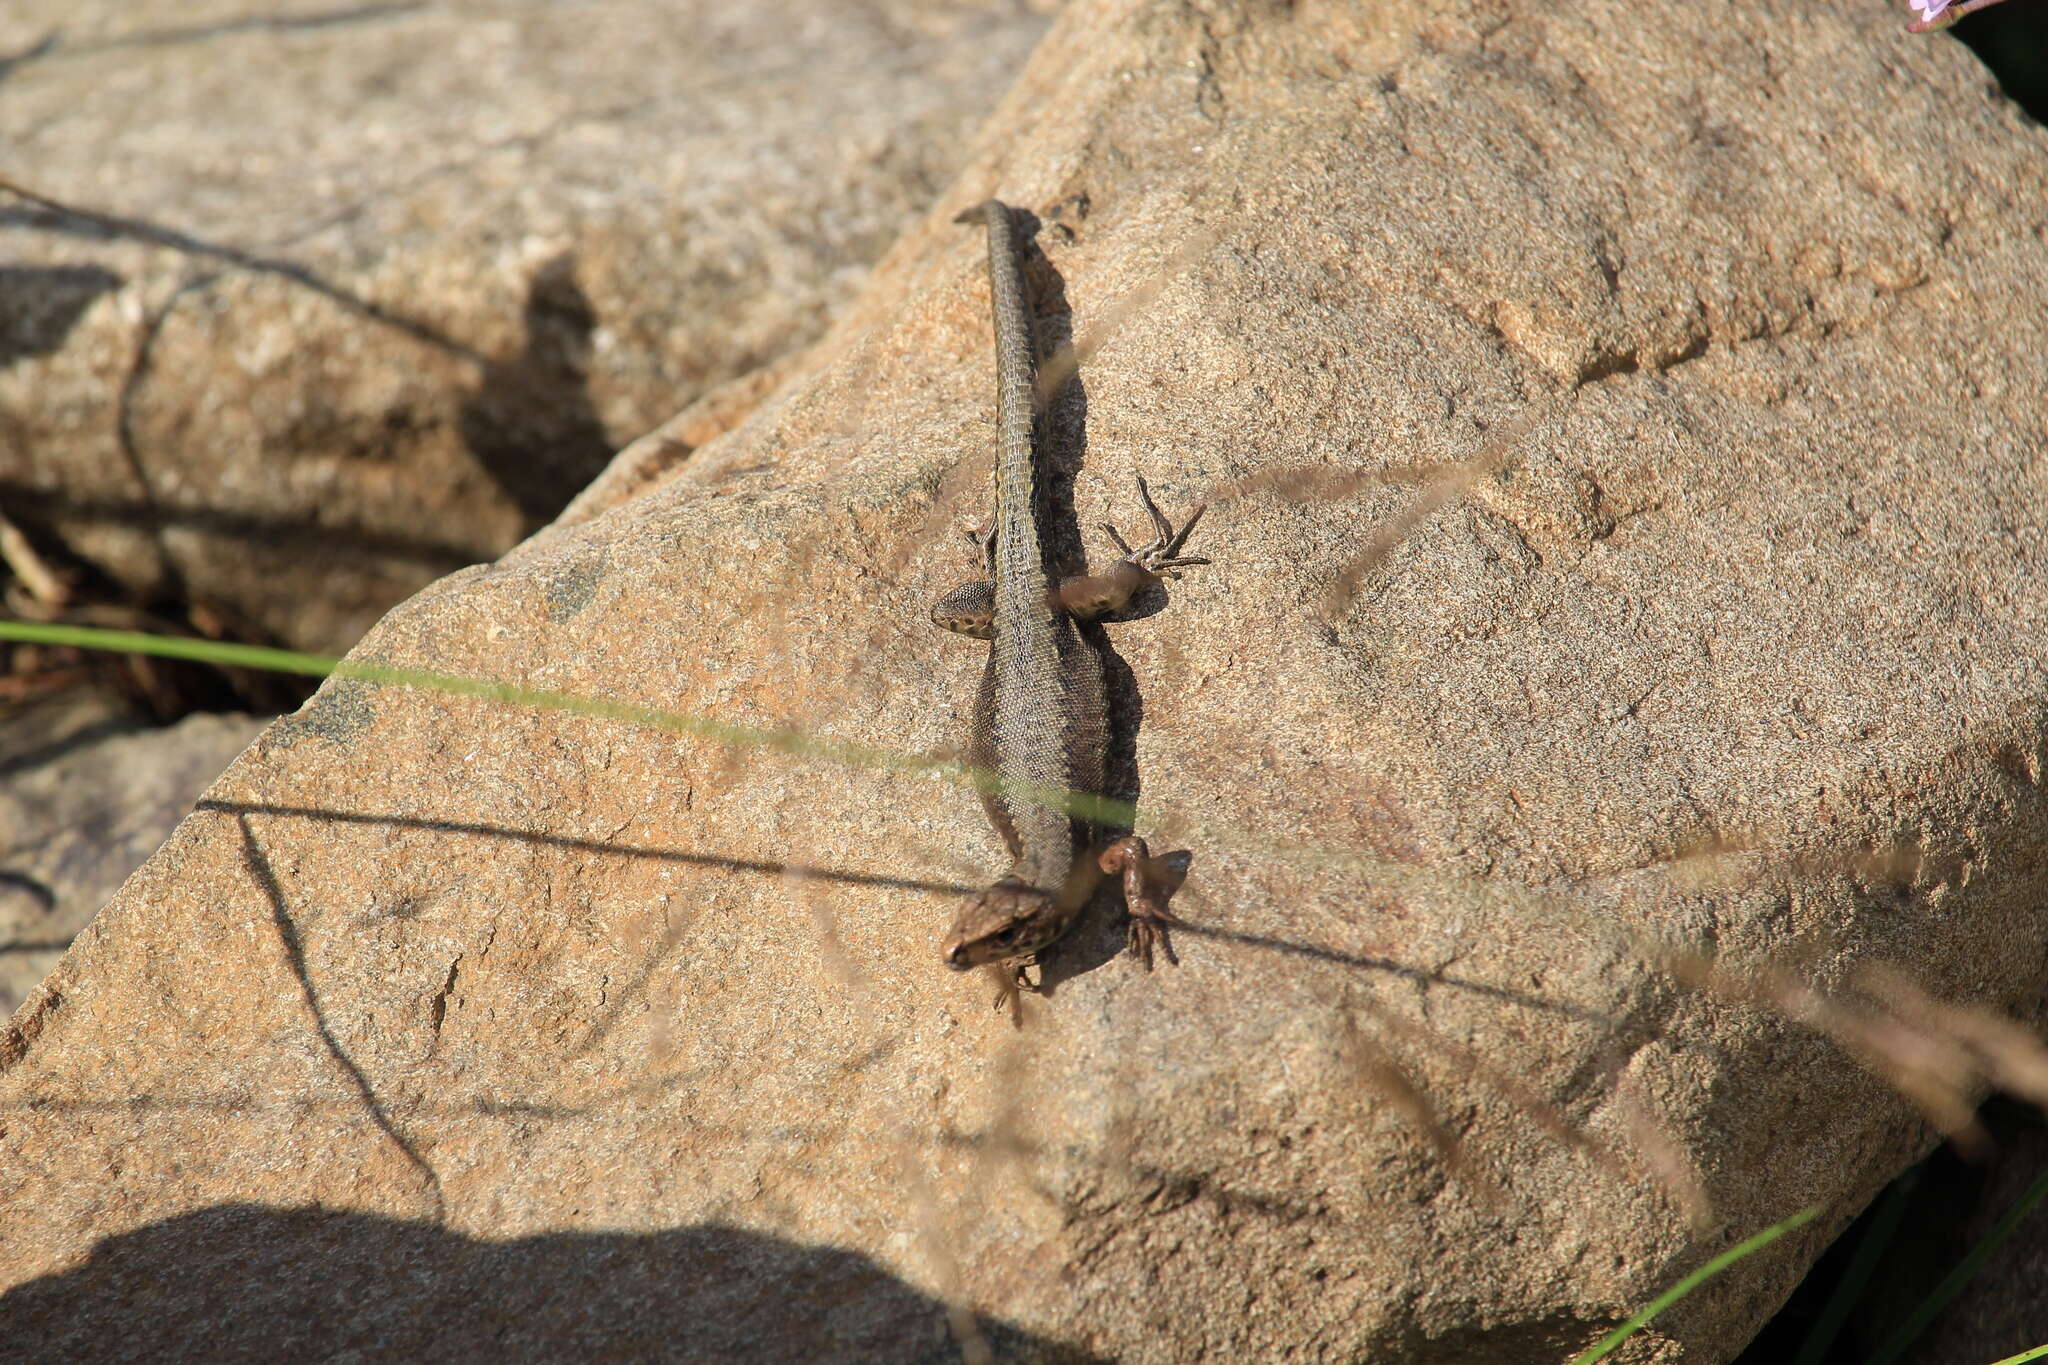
[0,0,2048,1365]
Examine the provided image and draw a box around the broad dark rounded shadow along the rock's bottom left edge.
[0,1203,1094,1363]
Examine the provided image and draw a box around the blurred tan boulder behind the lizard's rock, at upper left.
[0,0,1044,649]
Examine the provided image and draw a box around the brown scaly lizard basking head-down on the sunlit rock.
[932,199,1210,1027]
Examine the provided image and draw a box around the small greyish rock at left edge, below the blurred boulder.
[0,692,268,1013]
